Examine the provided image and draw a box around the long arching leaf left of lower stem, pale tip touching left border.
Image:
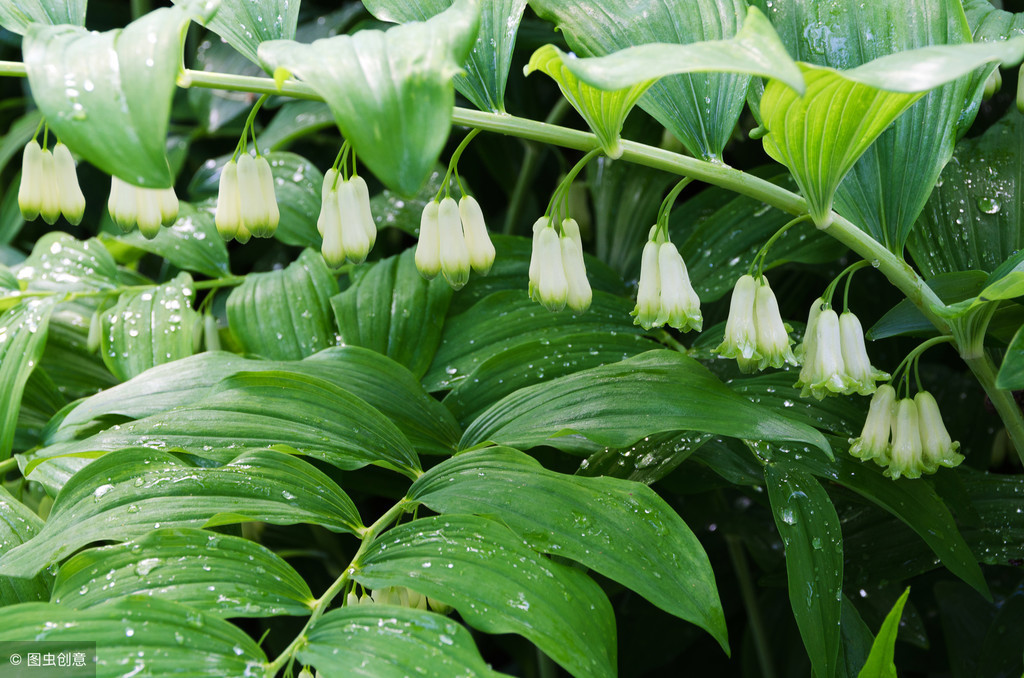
[0,449,362,577]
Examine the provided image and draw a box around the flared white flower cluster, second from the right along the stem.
[796,298,889,400]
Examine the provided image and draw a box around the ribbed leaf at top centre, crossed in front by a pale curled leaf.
[530,0,750,162]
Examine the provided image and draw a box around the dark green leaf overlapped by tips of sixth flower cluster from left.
[423,289,643,391]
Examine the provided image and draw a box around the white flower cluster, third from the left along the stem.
[215,153,281,243]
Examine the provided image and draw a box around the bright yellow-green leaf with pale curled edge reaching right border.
[760,38,1024,227]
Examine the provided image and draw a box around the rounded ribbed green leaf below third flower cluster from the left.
[227,250,338,361]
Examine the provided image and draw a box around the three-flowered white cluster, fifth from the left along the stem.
[416,196,495,290]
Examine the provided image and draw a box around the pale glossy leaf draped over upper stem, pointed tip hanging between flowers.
[259,0,480,195]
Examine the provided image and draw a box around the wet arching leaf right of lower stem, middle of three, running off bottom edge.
[352,515,615,678]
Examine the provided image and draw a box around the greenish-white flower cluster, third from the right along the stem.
[715,276,799,372]
